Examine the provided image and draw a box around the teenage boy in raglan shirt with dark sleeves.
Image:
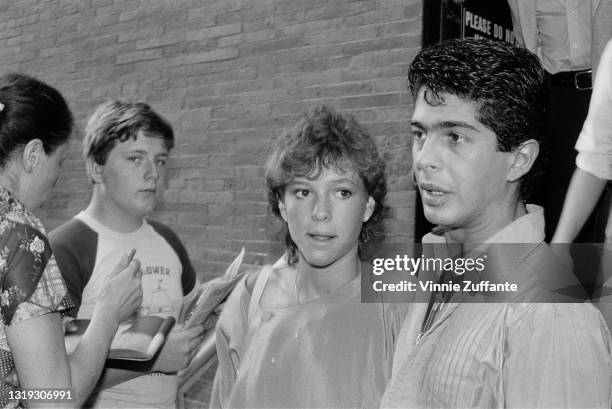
[50,101,203,407]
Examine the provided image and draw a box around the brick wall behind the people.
[0,0,422,406]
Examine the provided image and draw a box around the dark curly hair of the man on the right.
[408,38,550,200]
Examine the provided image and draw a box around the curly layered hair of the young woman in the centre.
[265,106,387,264]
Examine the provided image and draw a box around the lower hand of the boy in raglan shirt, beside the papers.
[153,325,205,373]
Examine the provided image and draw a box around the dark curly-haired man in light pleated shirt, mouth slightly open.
[382,39,612,408]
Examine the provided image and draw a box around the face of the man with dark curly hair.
[411,87,516,236]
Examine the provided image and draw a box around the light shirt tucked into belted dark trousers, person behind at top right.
[508,0,600,74]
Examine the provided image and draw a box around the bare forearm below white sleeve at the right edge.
[551,168,607,243]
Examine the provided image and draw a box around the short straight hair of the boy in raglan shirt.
[83,100,174,165]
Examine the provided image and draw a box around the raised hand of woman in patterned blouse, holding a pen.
[96,255,142,322]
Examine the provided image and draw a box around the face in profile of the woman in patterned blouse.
[19,142,68,209]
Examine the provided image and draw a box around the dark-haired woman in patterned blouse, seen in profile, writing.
[0,74,142,407]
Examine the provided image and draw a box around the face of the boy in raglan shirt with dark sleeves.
[101,133,168,218]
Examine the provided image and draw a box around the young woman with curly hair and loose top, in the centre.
[211,107,406,408]
